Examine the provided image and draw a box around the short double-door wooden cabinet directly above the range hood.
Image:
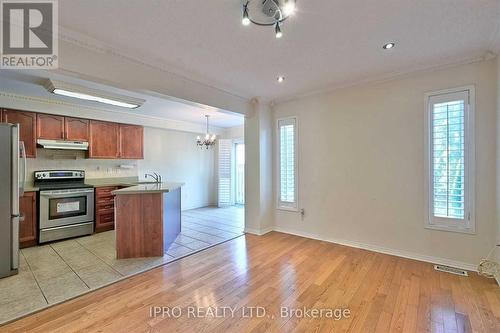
[37,113,89,141]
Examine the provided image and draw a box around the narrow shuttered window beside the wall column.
[278,118,298,210]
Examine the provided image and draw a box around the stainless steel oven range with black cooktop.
[35,170,94,243]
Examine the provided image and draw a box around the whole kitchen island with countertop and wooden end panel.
[113,182,184,259]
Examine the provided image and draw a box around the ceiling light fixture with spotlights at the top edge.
[241,0,296,38]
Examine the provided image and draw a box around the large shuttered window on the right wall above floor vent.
[427,87,475,233]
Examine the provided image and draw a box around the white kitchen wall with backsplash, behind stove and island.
[28,127,215,210]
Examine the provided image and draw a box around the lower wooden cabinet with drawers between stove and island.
[95,186,119,232]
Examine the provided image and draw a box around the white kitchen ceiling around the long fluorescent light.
[0,70,244,128]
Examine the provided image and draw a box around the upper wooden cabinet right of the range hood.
[89,120,120,159]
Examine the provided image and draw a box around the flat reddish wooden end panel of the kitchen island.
[115,193,164,259]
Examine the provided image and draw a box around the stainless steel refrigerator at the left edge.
[0,124,26,278]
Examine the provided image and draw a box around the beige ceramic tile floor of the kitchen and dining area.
[0,206,244,324]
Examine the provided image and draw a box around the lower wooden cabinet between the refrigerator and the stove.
[19,192,38,248]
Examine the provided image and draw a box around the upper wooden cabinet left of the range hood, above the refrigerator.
[2,109,36,157]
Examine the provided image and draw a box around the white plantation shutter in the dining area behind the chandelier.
[218,139,233,207]
